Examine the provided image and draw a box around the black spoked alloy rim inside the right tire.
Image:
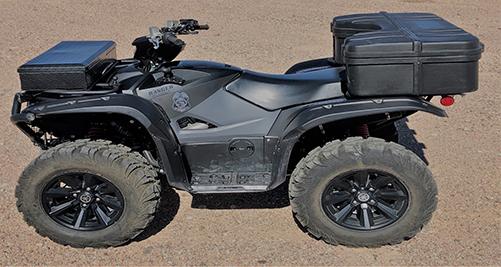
[322,170,409,231]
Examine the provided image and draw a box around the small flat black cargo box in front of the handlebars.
[17,41,116,90]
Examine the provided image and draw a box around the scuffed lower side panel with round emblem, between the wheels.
[183,136,277,191]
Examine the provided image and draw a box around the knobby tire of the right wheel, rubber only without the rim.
[289,137,437,247]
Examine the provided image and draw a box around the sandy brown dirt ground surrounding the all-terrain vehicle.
[0,0,501,265]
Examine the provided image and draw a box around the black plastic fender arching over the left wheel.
[11,94,188,190]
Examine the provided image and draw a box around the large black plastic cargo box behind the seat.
[332,12,483,96]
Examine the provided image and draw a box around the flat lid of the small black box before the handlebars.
[18,41,115,73]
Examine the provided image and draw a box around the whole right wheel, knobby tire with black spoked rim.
[289,137,437,247]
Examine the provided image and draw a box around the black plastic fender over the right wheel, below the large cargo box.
[269,97,447,189]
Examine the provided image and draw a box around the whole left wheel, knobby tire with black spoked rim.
[16,140,160,247]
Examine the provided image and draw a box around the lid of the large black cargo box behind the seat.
[331,12,483,63]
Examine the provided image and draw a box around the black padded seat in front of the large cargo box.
[226,67,344,110]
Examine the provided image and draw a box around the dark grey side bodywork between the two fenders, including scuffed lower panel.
[131,60,279,192]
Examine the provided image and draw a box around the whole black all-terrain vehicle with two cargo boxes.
[11,12,483,247]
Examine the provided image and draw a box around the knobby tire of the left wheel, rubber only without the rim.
[16,140,160,247]
